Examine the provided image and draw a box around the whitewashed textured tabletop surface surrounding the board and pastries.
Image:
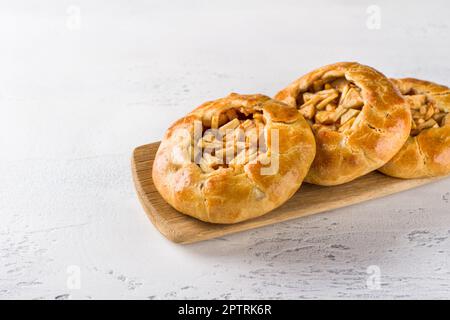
[0,0,450,299]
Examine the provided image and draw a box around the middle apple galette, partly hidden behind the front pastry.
[275,62,411,186]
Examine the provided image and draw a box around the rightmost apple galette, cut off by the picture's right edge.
[380,78,450,178]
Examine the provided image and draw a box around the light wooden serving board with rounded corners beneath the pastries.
[132,142,438,243]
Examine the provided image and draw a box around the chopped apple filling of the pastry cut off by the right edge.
[402,88,450,137]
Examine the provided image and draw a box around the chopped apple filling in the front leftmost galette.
[191,107,267,173]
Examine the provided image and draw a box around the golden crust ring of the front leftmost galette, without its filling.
[152,94,315,223]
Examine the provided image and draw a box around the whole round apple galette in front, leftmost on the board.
[152,93,315,223]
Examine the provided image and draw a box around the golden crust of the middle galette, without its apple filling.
[275,62,411,186]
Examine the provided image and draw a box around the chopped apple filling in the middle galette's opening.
[297,77,364,132]
